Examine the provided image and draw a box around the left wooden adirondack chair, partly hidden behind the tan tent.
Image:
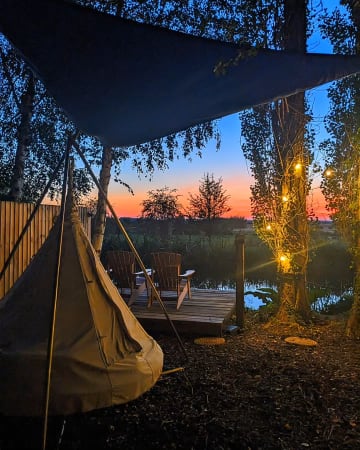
[105,250,150,306]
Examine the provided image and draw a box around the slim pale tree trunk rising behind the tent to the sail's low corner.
[91,147,113,255]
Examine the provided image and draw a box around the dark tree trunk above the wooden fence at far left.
[9,74,35,202]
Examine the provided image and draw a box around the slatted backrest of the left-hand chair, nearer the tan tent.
[106,250,135,289]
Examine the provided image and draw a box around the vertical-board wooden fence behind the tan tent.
[0,202,91,299]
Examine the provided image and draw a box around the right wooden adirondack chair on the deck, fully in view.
[148,252,195,309]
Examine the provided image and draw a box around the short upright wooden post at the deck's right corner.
[235,234,245,329]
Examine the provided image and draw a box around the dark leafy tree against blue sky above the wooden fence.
[0,36,93,202]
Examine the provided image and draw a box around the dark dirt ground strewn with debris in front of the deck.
[0,314,360,450]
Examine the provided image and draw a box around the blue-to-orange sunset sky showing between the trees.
[103,0,338,220]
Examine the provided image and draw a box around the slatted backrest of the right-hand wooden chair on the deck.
[151,252,181,292]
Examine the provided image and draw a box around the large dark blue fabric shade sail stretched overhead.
[0,0,360,146]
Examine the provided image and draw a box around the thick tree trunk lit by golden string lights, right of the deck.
[276,0,310,322]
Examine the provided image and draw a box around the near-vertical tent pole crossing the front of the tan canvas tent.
[42,134,77,450]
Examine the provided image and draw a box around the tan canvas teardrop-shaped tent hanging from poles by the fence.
[0,209,163,416]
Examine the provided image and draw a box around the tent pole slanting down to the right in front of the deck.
[73,141,187,359]
